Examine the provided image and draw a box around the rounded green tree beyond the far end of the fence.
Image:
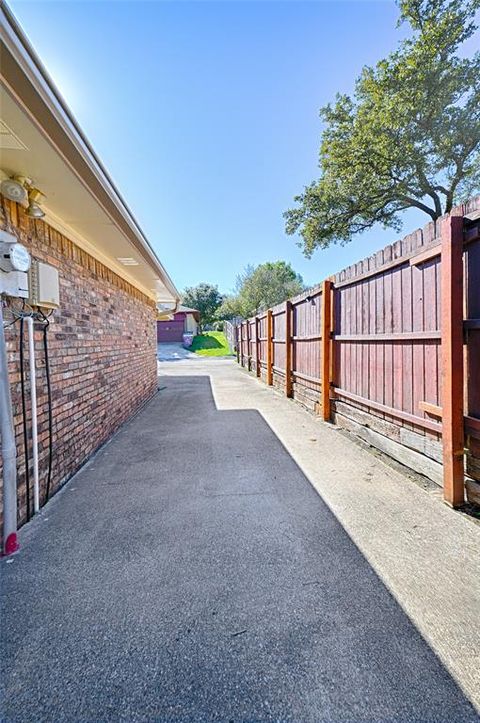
[218,261,304,319]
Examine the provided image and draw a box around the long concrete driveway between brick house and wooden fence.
[1,360,480,722]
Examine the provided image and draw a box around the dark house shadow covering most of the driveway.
[2,376,478,721]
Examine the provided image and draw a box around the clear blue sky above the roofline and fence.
[10,0,428,292]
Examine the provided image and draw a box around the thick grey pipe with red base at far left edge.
[0,300,19,555]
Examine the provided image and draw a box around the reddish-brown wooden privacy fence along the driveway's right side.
[236,196,480,507]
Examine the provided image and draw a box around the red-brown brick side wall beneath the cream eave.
[0,196,157,536]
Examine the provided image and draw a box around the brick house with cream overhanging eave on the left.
[0,5,179,552]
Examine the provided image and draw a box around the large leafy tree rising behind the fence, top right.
[284,0,480,256]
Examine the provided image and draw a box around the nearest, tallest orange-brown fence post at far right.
[441,216,464,507]
